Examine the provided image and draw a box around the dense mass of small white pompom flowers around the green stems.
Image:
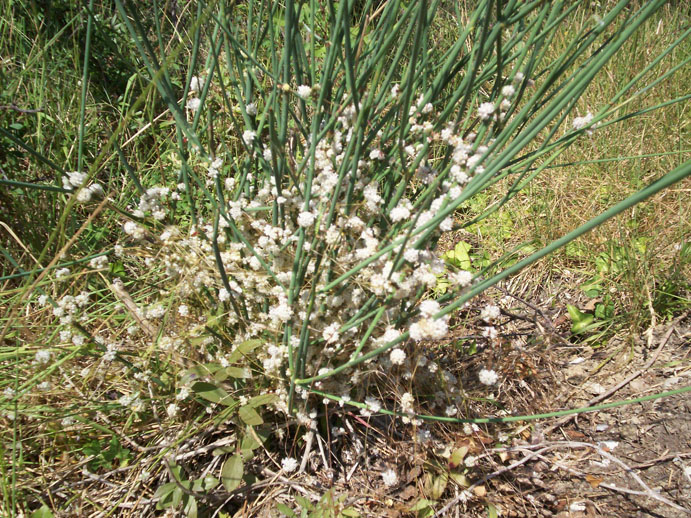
[102,84,515,422]
